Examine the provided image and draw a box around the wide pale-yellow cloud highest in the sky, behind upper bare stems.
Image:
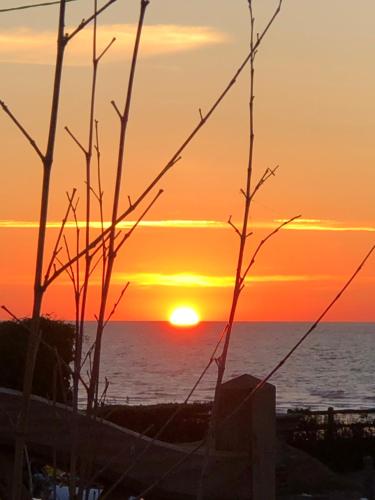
[0,24,229,66]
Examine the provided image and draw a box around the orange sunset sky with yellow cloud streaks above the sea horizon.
[0,0,375,321]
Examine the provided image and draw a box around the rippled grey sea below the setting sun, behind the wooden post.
[85,321,375,413]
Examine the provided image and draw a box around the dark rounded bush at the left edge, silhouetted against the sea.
[0,317,74,402]
